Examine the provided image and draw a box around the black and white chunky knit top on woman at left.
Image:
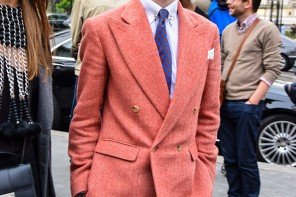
[0,5,38,138]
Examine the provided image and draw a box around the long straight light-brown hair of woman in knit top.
[20,0,52,80]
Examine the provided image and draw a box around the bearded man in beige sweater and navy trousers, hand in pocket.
[219,0,282,197]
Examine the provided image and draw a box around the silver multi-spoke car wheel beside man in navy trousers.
[258,114,296,167]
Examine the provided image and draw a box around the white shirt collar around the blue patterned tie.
[141,0,178,24]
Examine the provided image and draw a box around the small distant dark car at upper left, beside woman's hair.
[47,13,69,32]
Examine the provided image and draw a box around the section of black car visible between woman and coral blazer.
[51,29,75,130]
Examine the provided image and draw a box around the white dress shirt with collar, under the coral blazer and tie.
[141,0,179,98]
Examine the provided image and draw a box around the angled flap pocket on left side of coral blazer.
[95,139,140,161]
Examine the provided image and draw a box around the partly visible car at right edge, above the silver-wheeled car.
[281,35,296,71]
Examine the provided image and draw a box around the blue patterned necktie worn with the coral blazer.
[155,9,172,92]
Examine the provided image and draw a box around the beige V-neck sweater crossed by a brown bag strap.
[221,20,283,100]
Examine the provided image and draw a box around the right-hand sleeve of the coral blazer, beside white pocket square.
[196,25,221,183]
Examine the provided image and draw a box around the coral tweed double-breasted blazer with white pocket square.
[69,0,220,197]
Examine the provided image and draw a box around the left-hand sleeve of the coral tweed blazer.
[68,19,109,196]
